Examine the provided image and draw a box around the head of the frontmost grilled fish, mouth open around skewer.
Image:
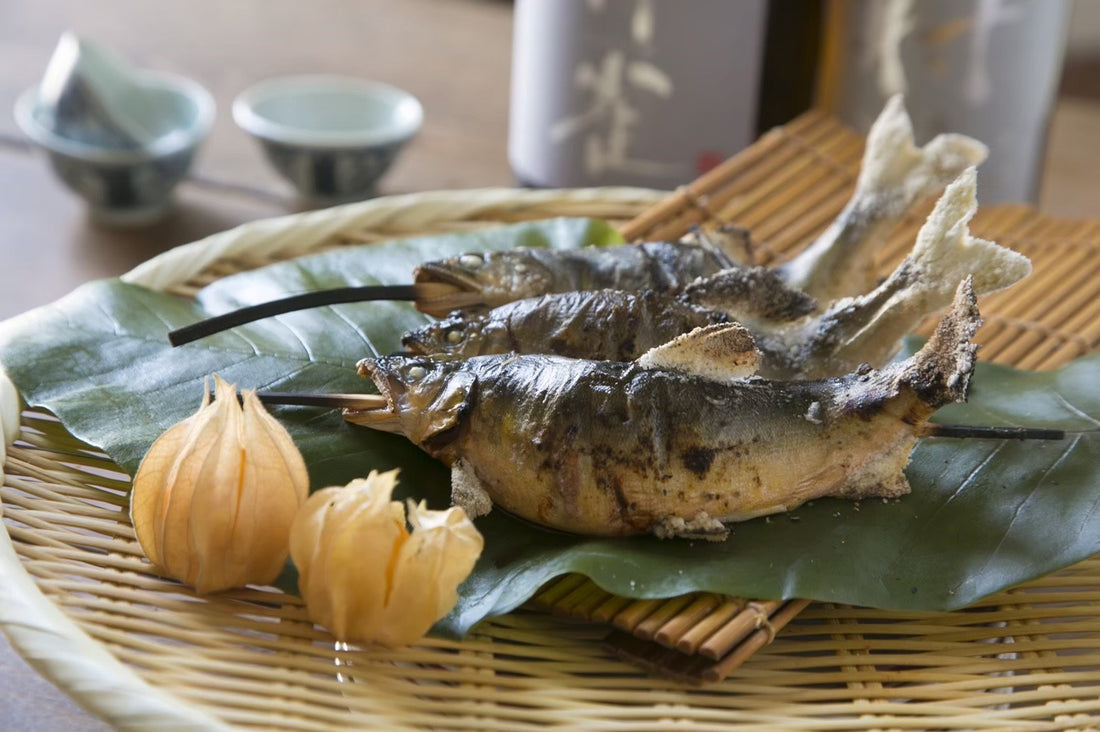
[344,356,477,455]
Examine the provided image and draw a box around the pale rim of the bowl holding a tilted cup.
[13,72,217,165]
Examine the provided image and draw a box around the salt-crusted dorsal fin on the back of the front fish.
[637,323,760,381]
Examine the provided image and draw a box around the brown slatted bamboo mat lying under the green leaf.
[534,112,1100,682]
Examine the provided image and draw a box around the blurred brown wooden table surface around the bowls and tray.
[0,0,1100,731]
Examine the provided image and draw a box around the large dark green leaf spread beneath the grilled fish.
[0,214,1100,633]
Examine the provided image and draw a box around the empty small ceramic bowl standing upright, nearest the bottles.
[233,76,424,204]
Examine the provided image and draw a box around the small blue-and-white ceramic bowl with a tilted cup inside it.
[15,73,215,226]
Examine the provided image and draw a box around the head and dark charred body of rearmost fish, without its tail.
[414,242,735,317]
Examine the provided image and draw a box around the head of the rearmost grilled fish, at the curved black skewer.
[413,250,553,317]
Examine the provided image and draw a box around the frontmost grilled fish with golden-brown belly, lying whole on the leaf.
[345,282,980,538]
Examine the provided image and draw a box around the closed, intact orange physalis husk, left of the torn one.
[130,375,309,592]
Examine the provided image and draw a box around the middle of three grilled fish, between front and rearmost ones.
[403,168,1031,379]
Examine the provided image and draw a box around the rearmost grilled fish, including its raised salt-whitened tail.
[414,95,988,317]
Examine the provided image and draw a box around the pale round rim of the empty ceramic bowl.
[232,74,424,149]
